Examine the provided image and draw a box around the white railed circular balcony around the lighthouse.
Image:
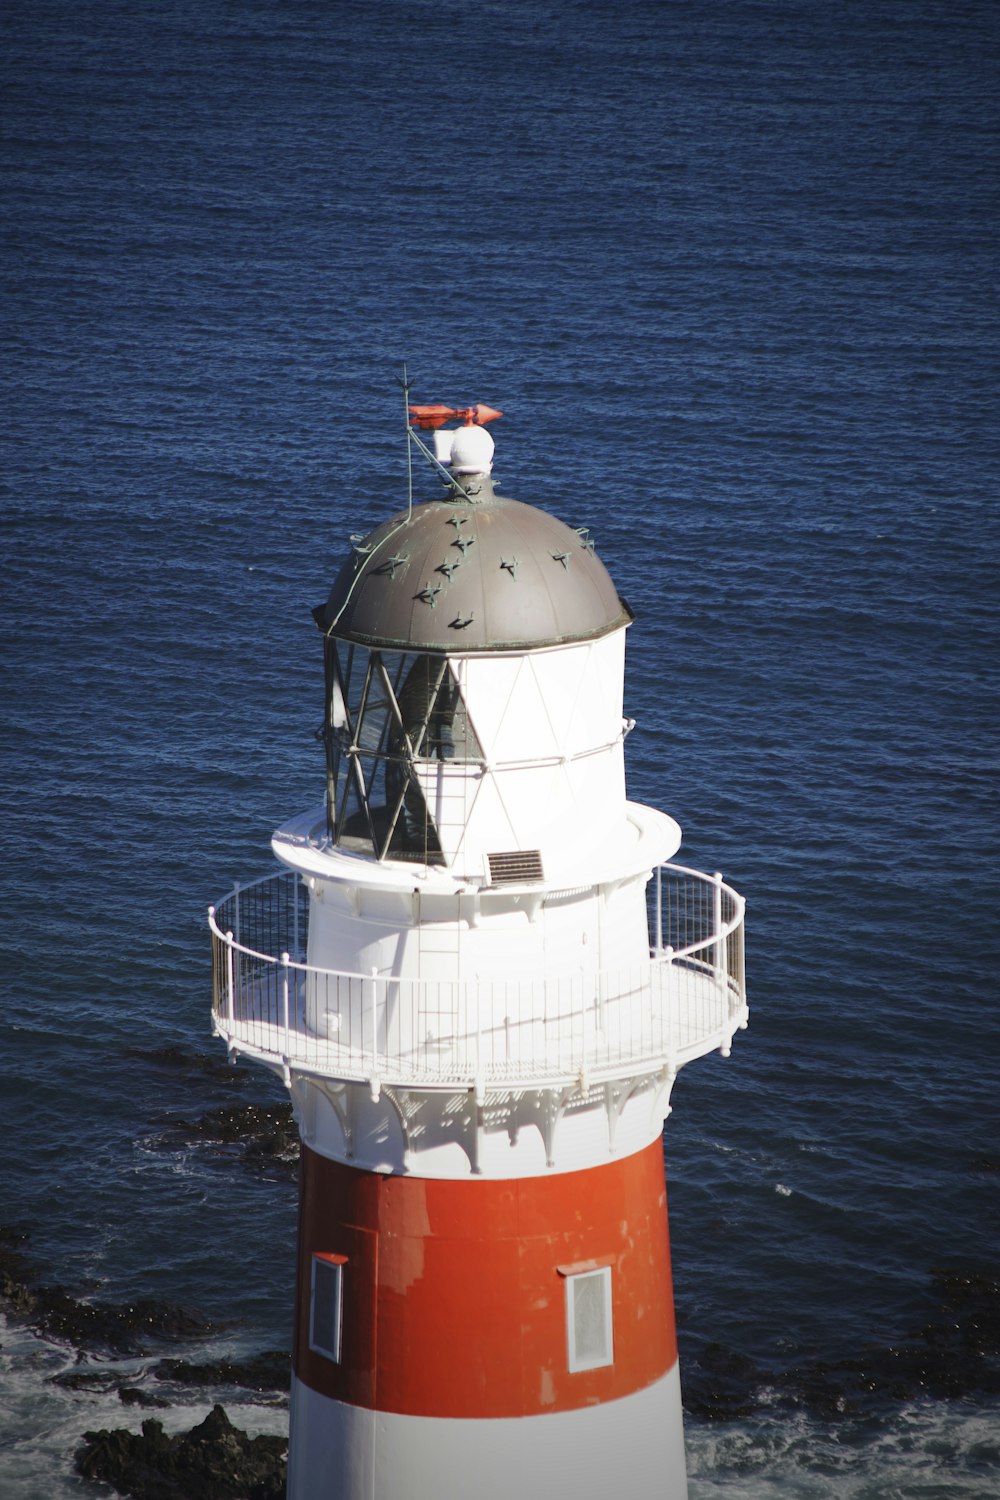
[208,864,747,1092]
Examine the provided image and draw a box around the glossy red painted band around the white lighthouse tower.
[294,1142,676,1418]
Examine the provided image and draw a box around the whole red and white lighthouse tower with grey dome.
[210,405,747,1500]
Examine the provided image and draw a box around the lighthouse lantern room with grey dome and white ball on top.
[305,428,676,884]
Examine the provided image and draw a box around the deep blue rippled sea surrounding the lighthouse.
[0,0,1000,1500]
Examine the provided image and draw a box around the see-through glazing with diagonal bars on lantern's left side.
[324,641,483,864]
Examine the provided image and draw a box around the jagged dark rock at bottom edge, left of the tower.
[75,1406,288,1500]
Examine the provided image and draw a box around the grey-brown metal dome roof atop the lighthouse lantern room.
[313,476,633,653]
